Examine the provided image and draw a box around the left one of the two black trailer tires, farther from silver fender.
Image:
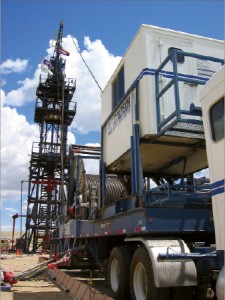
[107,246,131,300]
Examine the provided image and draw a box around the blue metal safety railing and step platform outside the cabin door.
[155,49,224,138]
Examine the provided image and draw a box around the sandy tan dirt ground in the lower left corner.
[0,254,72,300]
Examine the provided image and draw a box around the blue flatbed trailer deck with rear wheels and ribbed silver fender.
[51,152,223,299]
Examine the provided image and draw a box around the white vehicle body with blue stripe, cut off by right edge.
[201,66,225,300]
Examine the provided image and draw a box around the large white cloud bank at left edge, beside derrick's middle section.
[1,107,39,201]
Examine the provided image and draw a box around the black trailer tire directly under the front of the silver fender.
[130,247,169,300]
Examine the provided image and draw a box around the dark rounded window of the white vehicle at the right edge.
[210,97,224,142]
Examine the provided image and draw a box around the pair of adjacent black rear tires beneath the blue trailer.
[107,246,192,300]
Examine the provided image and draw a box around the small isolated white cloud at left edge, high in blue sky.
[1,58,28,74]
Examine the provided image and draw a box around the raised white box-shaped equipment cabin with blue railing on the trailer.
[101,25,224,177]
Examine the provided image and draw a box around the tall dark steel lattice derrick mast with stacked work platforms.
[26,22,76,252]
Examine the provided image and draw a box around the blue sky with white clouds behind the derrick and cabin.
[1,0,224,230]
